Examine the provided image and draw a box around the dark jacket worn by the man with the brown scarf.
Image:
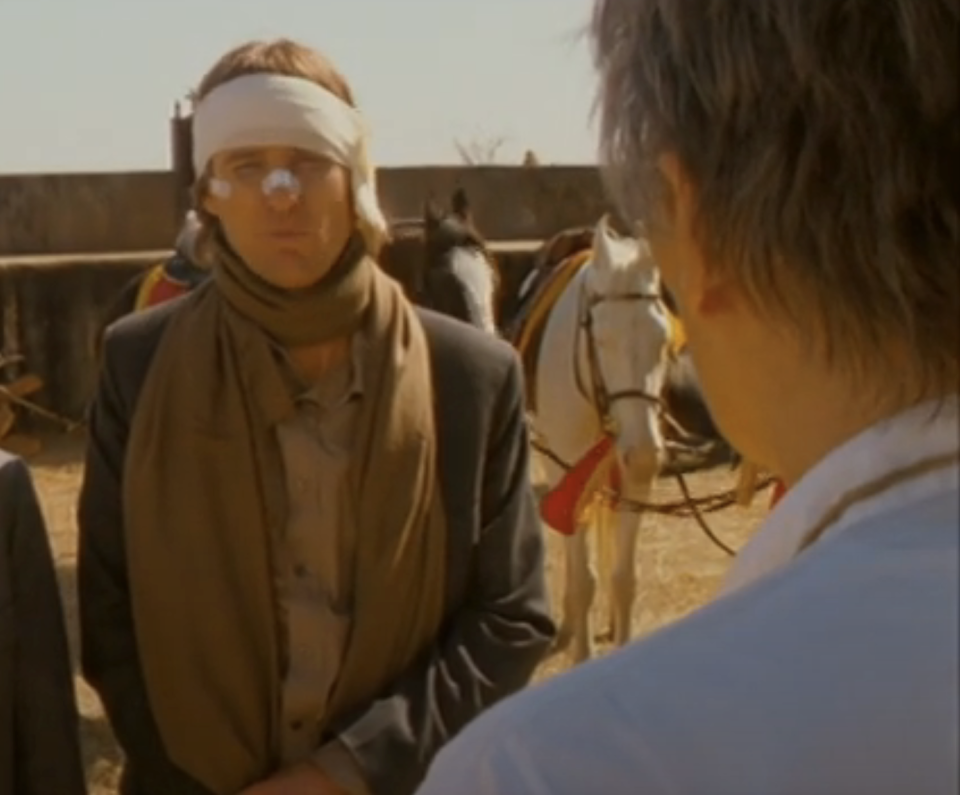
[78,299,555,795]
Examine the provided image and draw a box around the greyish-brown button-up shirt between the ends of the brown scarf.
[275,335,365,793]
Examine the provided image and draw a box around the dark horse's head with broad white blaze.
[423,188,500,334]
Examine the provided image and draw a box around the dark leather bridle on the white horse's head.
[572,279,663,433]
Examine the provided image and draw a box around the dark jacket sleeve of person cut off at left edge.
[0,451,86,795]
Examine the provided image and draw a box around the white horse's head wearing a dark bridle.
[581,217,669,483]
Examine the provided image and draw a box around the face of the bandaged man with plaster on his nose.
[204,146,354,290]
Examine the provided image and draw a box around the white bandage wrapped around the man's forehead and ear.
[193,74,387,234]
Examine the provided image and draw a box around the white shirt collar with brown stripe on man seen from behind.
[723,395,960,593]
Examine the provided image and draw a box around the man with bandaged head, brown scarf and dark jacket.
[79,40,554,795]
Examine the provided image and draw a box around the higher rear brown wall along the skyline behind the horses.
[0,166,610,257]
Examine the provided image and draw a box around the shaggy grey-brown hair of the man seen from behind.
[593,0,960,402]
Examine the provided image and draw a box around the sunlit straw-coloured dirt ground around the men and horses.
[30,437,768,795]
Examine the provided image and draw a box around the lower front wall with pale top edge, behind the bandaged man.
[0,243,536,422]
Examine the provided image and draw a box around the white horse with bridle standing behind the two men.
[525,217,669,662]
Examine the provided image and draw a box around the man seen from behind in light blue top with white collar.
[419,0,960,795]
